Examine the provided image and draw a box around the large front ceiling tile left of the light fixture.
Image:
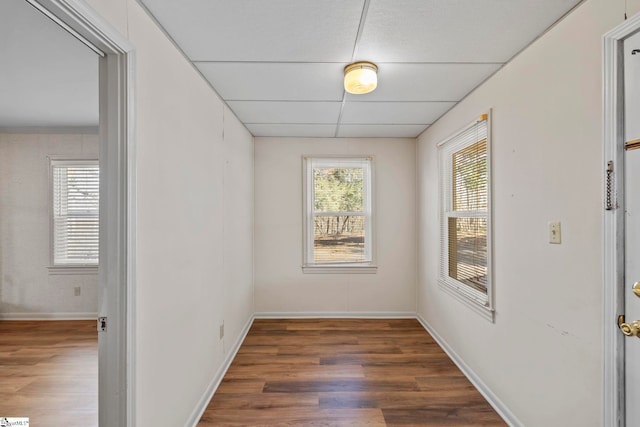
[142,0,364,62]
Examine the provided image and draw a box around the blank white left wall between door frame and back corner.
[72,0,253,427]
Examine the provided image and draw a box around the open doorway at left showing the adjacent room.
[0,0,99,427]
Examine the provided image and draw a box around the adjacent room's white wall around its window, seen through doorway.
[0,133,98,319]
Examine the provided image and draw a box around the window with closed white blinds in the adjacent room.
[51,160,100,267]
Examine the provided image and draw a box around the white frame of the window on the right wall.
[437,110,495,322]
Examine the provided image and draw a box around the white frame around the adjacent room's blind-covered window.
[47,156,100,275]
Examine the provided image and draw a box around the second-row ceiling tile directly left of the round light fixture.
[196,62,346,101]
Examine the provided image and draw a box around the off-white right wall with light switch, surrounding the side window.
[418,0,637,427]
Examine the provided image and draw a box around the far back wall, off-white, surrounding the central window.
[255,138,416,313]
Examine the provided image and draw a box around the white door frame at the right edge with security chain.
[602,14,640,427]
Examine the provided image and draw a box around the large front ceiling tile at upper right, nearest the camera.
[356,0,580,62]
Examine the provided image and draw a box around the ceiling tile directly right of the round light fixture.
[347,63,501,101]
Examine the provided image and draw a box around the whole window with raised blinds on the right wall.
[438,114,493,319]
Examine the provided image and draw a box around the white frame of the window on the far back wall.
[302,156,378,274]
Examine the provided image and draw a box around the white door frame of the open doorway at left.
[27,0,136,427]
